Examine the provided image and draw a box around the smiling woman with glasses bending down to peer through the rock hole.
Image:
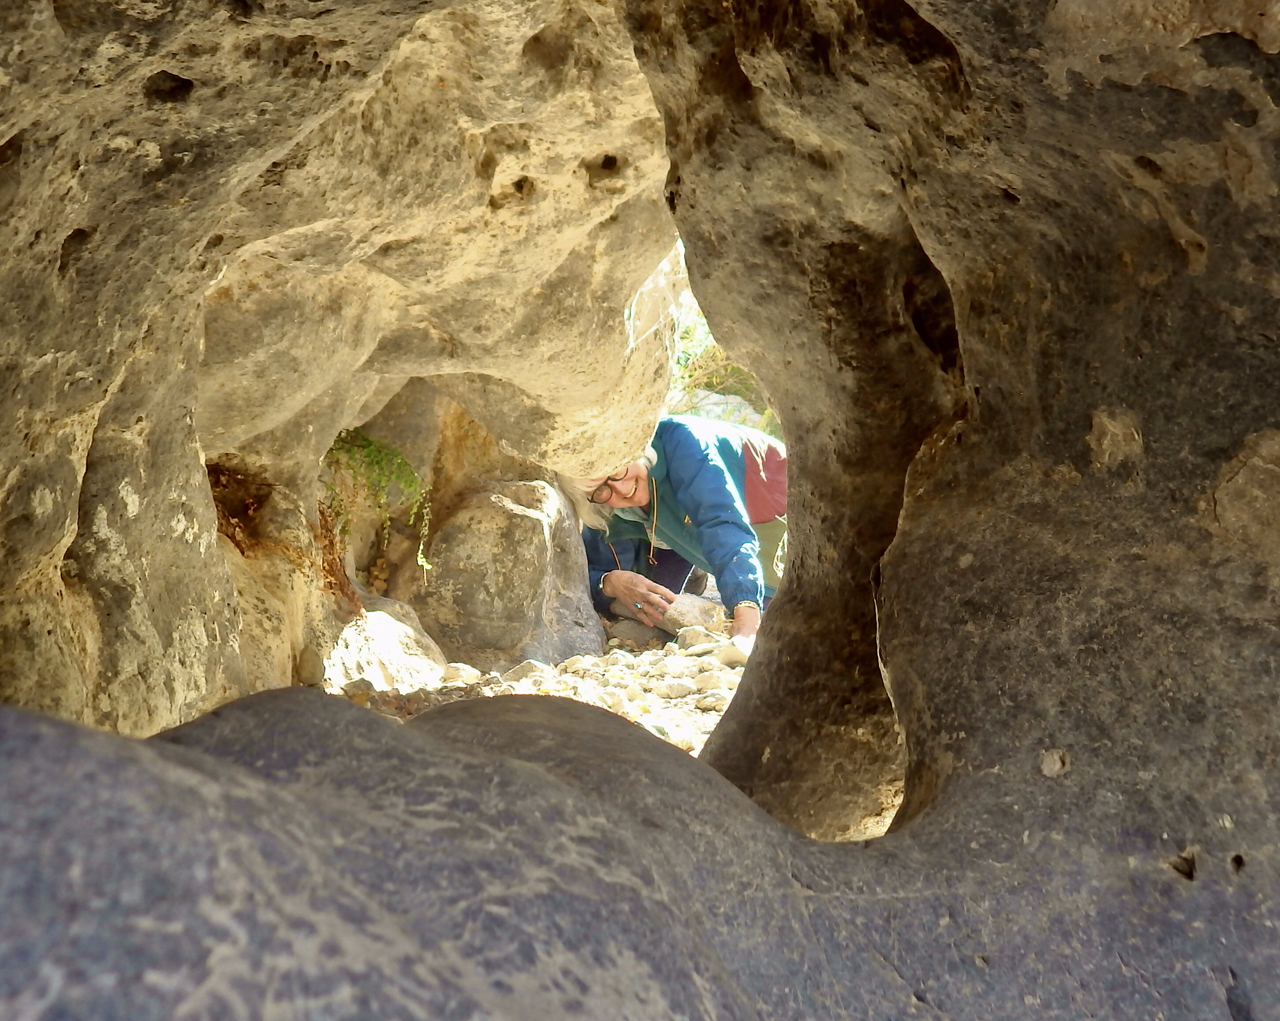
[563,416,787,636]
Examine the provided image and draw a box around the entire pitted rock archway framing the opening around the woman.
[0,0,1280,1021]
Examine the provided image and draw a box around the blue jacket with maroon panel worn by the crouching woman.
[582,416,786,608]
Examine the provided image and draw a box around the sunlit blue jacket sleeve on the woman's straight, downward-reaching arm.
[663,426,764,612]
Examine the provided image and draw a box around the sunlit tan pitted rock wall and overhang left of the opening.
[0,0,673,733]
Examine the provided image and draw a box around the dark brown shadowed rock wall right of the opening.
[627,0,1280,839]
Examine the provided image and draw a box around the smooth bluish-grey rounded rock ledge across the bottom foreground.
[0,691,1280,1021]
